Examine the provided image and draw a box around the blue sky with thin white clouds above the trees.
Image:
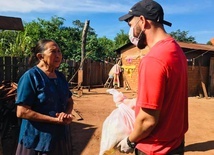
[0,0,214,44]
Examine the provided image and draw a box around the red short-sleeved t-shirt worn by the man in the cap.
[135,37,188,155]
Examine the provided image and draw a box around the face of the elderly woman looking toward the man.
[42,42,62,68]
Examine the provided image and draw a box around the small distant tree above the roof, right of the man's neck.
[169,29,196,43]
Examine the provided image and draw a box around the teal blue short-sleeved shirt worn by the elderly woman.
[16,66,72,151]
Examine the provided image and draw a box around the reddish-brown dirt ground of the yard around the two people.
[72,88,214,155]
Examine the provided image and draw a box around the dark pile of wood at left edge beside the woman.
[0,81,19,155]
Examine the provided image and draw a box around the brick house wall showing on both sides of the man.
[121,46,210,96]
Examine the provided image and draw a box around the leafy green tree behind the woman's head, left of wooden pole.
[25,16,81,60]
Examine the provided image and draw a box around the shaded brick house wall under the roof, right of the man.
[183,48,214,97]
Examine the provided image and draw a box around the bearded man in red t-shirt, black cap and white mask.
[117,0,188,155]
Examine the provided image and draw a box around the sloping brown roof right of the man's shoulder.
[178,42,214,52]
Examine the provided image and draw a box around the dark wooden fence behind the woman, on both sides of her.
[0,57,114,87]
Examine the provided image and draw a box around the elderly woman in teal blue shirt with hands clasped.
[16,39,73,155]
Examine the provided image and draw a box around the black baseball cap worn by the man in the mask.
[119,0,172,26]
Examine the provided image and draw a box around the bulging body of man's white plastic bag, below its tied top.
[99,103,135,155]
